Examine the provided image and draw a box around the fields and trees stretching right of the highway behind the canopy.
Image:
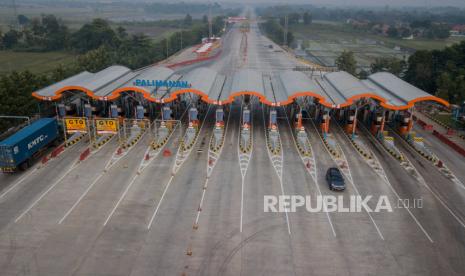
[257,5,465,104]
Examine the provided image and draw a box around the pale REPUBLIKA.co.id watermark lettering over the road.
[263,195,423,213]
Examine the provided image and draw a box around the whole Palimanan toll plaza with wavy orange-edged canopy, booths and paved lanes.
[0,14,465,275]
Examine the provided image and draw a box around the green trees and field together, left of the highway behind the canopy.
[0,14,224,132]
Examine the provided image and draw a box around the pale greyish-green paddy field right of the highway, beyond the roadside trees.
[290,21,463,70]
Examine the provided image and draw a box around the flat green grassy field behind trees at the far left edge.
[0,51,75,75]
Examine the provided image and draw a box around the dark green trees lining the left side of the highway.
[0,16,224,132]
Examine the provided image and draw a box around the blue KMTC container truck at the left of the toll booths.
[0,118,59,172]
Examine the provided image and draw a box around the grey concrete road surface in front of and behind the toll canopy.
[0,9,465,276]
